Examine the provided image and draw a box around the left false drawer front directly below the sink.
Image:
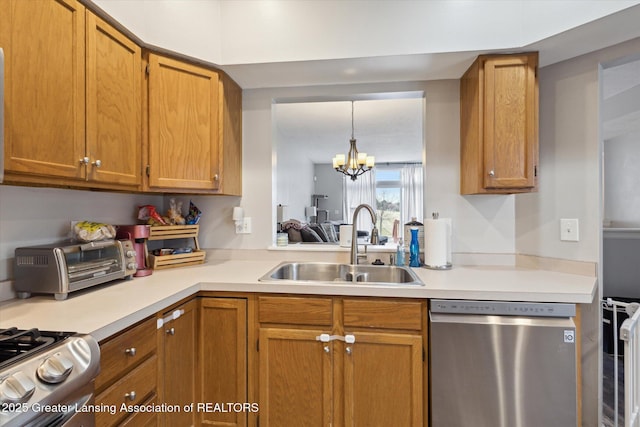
[258,297,333,326]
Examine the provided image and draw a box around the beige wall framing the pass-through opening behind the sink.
[199,80,515,254]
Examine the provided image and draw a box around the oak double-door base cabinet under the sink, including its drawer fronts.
[258,296,427,427]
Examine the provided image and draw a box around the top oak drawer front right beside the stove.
[96,318,157,391]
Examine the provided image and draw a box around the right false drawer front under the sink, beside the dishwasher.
[343,299,423,331]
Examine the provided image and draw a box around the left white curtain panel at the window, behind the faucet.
[342,169,376,231]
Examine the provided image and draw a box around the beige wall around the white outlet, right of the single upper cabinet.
[515,39,640,262]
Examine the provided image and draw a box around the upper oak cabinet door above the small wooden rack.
[148,54,220,190]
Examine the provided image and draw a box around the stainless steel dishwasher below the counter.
[429,300,578,427]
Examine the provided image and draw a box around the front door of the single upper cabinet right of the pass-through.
[484,55,537,189]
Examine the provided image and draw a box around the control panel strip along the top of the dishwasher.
[431,299,576,317]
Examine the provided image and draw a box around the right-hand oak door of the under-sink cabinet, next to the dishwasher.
[344,332,424,427]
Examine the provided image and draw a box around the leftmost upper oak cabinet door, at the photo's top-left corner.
[0,0,85,178]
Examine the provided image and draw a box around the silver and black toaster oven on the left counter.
[13,240,137,300]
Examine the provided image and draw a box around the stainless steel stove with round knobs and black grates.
[0,327,100,427]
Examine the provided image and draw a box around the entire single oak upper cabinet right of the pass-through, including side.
[460,52,538,194]
